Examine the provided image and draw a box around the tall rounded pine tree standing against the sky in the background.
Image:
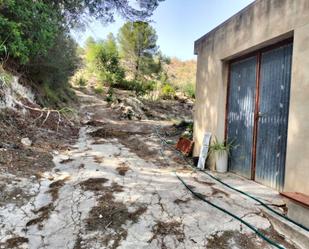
[118,21,160,80]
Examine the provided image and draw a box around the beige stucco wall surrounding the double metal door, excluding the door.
[194,0,309,194]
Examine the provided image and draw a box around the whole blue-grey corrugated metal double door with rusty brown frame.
[227,40,292,190]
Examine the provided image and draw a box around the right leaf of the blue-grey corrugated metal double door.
[255,44,292,190]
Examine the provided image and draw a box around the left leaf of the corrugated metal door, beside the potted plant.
[227,56,257,178]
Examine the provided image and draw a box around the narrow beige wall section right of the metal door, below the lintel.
[285,22,309,195]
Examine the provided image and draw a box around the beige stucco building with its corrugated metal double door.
[194,0,309,226]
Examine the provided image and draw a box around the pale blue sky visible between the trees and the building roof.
[74,0,253,60]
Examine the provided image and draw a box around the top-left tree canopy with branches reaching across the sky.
[0,0,161,64]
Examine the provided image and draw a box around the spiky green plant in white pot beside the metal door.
[209,137,232,173]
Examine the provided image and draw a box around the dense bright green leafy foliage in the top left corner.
[0,0,60,64]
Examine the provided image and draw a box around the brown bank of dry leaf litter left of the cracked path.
[0,109,79,177]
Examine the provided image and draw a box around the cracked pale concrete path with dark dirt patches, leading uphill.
[0,92,296,249]
